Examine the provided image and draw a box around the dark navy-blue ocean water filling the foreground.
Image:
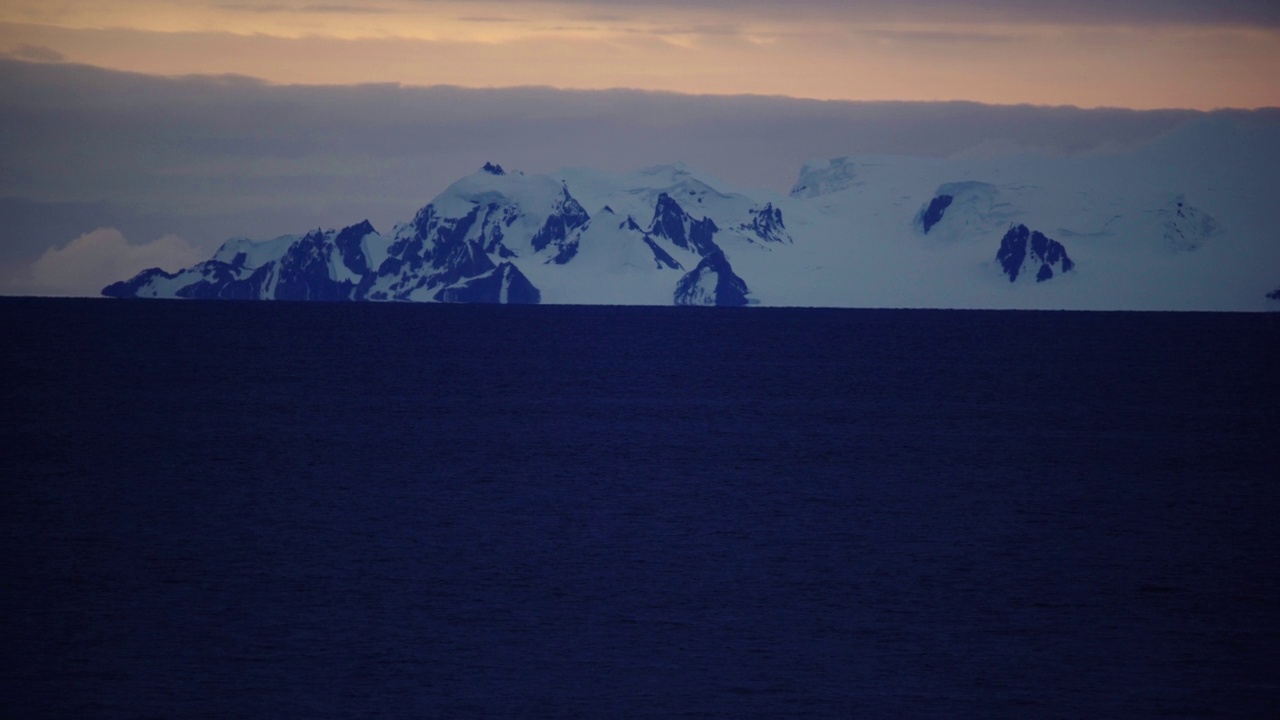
[0,299,1280,719]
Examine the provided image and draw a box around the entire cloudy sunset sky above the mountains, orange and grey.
[0,0,1280,295]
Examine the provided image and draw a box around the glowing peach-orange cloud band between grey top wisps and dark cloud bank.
[0,14,1280,109]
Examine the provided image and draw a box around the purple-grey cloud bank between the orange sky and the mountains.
[0,59,1249,271]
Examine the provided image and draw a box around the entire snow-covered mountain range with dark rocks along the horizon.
[102,123,1280,310]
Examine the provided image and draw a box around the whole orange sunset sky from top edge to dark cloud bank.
[0,0,1280,109]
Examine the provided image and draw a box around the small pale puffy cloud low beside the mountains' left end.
[12,228,204,297]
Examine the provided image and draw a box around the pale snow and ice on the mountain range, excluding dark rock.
[99,114,1280,310]
